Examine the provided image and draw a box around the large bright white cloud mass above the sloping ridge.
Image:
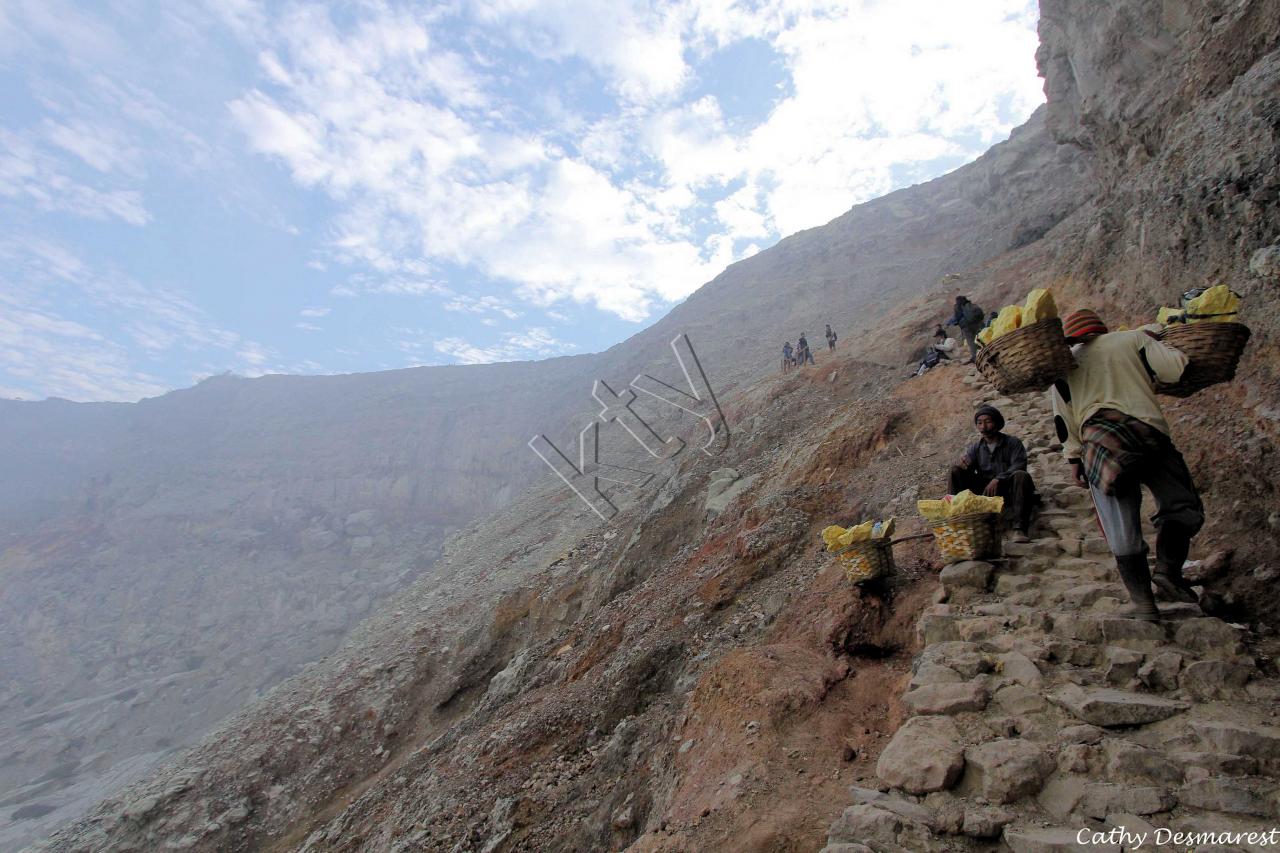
[217,0,1042,320]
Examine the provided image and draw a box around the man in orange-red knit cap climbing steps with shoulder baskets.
[1051,310,1204,622]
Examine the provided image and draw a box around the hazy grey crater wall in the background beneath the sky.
[0,56,1087,843]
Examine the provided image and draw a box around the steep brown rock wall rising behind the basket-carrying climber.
[1037,0,1280,628]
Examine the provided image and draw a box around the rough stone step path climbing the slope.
[822,377,1280,853]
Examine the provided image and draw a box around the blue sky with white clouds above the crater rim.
[0,0,1044,401]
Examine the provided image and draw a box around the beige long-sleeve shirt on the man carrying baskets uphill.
[1050,329,1187,460]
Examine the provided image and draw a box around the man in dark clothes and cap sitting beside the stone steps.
[947,406,1039,542]
